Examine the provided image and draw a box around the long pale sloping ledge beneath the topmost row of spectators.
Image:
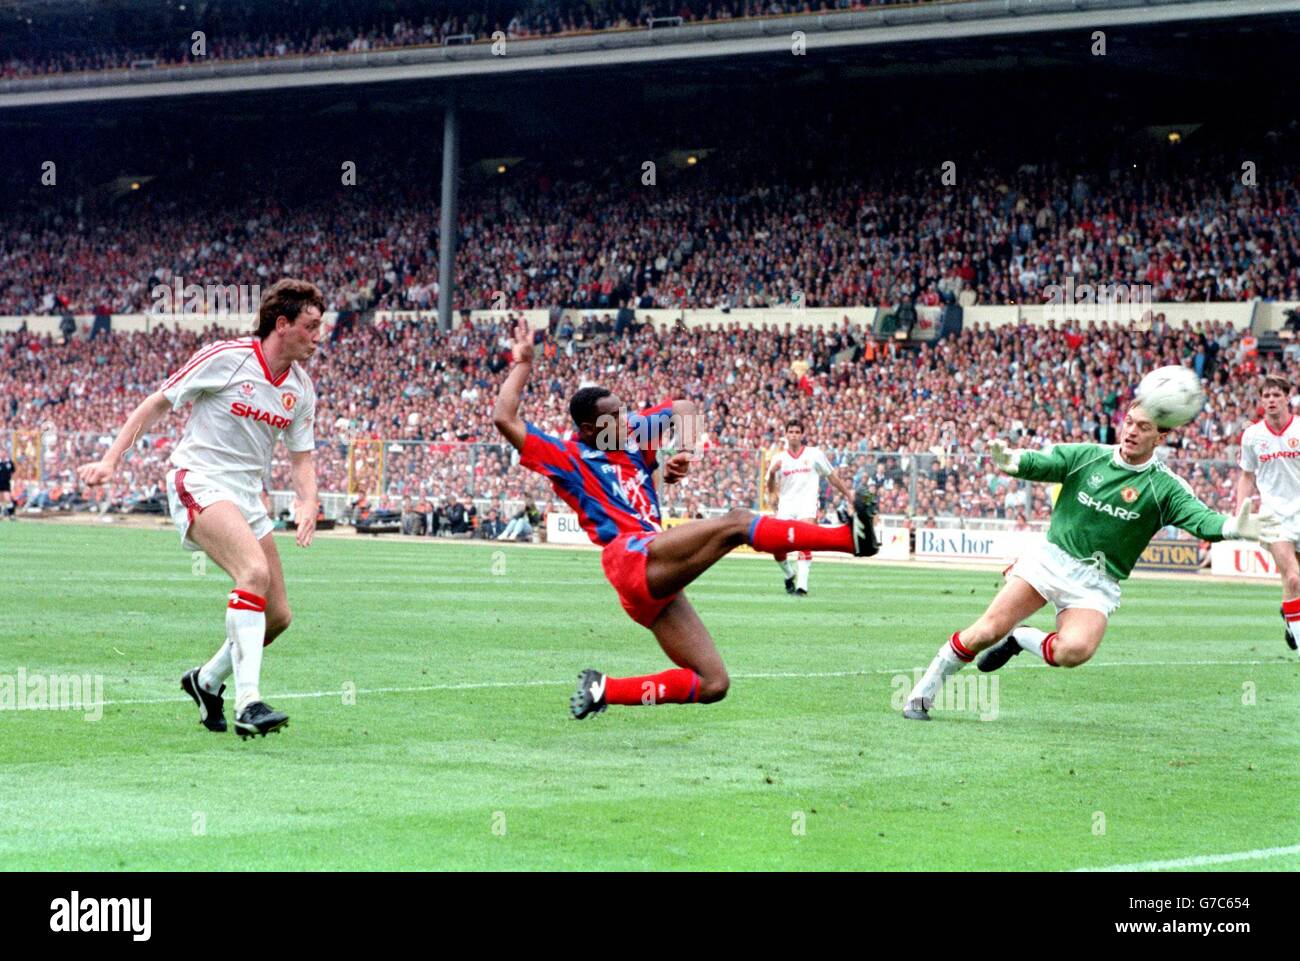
[0,0,1300,108]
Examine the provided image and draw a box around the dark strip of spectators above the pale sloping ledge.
[0,0,931,78]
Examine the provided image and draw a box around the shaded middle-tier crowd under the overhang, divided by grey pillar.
[0,156,1300,323]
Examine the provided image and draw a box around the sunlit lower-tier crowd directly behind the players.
[0,315,1279,524]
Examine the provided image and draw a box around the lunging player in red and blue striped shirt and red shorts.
[494,323,879,719]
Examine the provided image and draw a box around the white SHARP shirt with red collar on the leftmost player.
[161,337,316,495]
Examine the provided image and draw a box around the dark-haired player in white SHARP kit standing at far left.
[78,278,325,739]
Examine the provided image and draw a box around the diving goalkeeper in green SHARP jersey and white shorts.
[902,406,1278,720]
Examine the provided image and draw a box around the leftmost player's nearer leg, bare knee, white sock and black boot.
[189,501,289,737]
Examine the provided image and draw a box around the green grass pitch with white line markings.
[0,523,1300,870]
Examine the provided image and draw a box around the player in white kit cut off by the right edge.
[1236,377,1300,650]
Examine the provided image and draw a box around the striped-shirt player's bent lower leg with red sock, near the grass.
[569,594,731,720]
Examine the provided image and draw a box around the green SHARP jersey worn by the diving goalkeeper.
[1014,443,1227,580]
